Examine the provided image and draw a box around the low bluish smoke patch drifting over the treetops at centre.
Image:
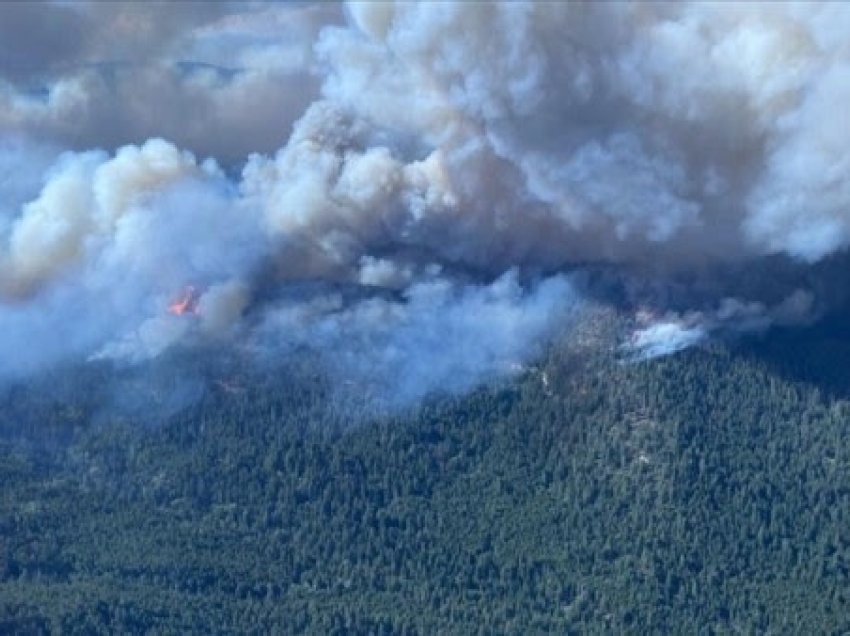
[255,271,578,406]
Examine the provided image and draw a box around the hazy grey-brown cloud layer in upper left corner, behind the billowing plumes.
[0,1,341,162]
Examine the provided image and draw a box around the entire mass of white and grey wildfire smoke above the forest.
[0,2,850,399]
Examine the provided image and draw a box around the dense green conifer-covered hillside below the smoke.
[0,336,850,634]
